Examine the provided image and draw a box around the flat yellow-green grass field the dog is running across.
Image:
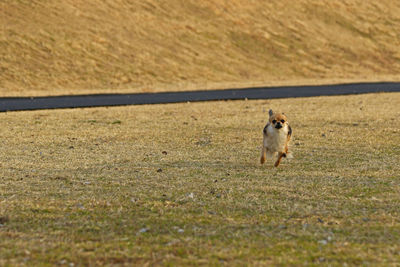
[0,93,400,266]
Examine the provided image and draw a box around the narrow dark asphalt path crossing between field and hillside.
[0,82,400,112]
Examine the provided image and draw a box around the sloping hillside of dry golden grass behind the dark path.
[0,0,400,96]
